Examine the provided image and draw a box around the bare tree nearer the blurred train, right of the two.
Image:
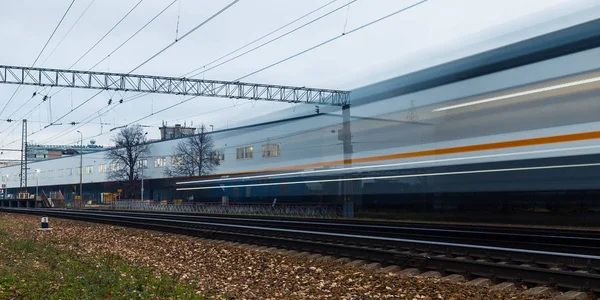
[165,124,221,177]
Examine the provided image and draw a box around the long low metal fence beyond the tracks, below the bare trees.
[111,200,343,218]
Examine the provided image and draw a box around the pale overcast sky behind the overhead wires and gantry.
[0,0,593,159]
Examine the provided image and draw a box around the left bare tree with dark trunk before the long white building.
[106,125,149,192]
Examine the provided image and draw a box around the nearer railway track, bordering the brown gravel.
[0,208,600,293]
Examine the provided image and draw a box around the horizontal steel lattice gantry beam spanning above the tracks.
[0,66,350,106]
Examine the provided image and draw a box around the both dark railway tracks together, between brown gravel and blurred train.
[1,208,600,295]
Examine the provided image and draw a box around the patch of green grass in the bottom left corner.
[0,230,214,299]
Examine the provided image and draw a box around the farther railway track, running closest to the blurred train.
[79,211,600,255]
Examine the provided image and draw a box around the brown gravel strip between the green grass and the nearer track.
[0,213,564,300]
